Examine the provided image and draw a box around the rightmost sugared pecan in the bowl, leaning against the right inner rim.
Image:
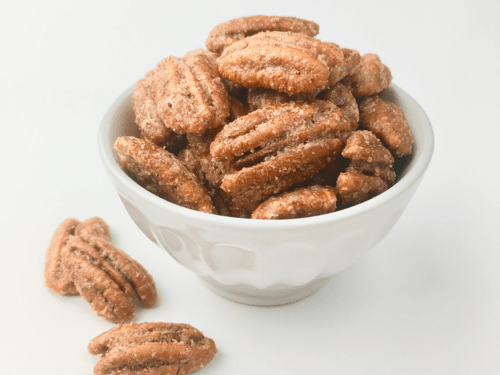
[359,95,413,156]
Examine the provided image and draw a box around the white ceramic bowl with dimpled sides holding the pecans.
[99,84,434,305]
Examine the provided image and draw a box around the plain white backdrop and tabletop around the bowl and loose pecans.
[0,0,500,375]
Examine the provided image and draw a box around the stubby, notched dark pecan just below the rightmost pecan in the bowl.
[337,130,396,204]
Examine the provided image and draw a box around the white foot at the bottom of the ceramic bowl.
[198,276,331,306]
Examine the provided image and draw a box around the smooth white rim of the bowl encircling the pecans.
[98,83,434,231]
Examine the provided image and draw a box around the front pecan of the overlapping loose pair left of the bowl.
[62,234,158,323]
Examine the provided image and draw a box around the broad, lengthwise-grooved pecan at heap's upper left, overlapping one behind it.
[152,49,229,133]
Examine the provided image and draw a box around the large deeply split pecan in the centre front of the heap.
[210,100,351,211]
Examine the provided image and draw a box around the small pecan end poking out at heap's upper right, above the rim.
[342,53,392,98]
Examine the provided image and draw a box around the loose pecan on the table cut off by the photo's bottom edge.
[88,322,217,375]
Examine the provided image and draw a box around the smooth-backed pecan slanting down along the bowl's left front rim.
[114,137,214,213]
